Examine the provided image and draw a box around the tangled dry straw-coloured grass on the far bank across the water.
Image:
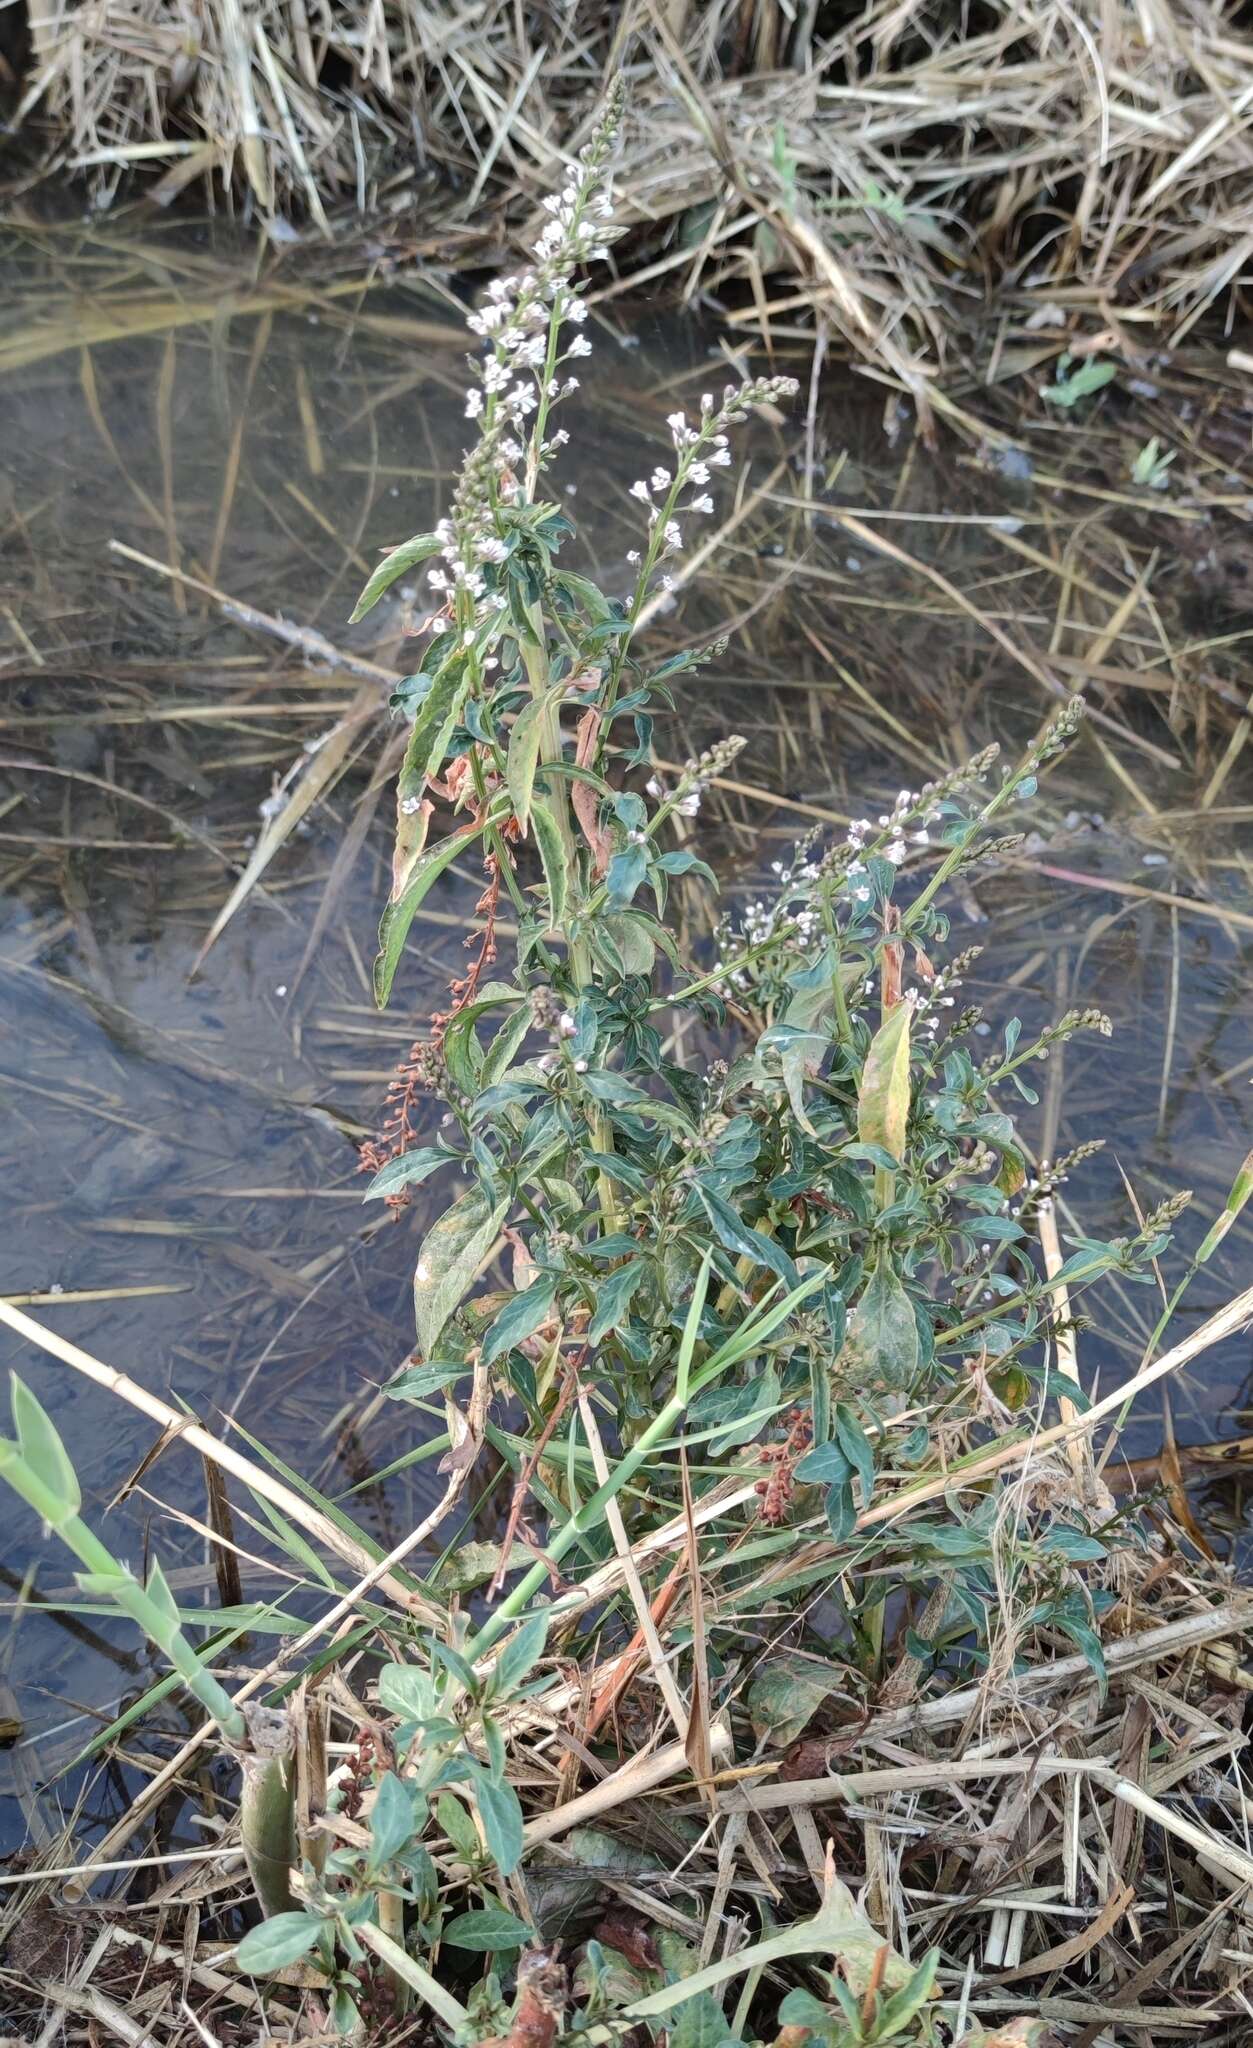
[14,0,1253,387]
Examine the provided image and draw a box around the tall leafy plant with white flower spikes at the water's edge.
[358,98,1179,1671]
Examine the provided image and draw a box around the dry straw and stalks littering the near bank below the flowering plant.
[0,1290,1253,2048]
